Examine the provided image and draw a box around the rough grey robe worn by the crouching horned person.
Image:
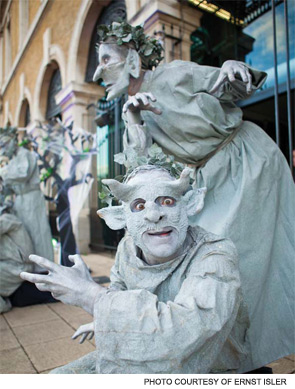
[53,227,248,374]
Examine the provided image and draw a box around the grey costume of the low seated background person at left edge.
[0,209,33,313]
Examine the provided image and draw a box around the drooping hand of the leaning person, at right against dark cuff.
[209,60,252,94]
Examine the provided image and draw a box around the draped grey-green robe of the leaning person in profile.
[133,61,295,371]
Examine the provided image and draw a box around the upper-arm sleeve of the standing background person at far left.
[0,152,36,185]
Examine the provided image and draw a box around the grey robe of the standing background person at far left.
[0,147,53,261]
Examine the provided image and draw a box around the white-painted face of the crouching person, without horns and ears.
[124,170,189,265]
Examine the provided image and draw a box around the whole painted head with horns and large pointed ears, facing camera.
[98,165,205,264]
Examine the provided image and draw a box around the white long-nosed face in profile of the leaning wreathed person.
[93,43,130,100]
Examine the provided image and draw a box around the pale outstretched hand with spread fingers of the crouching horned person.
[20,254,104,314]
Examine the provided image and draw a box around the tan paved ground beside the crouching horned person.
[0,253,295,374]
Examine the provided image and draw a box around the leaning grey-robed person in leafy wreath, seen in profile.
[94,23,295,370]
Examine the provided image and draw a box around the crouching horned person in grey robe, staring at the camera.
[21,165,249,374]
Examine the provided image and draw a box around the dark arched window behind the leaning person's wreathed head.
[85,0,126,82]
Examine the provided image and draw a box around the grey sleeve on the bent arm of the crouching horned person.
[94,246,240,374]
